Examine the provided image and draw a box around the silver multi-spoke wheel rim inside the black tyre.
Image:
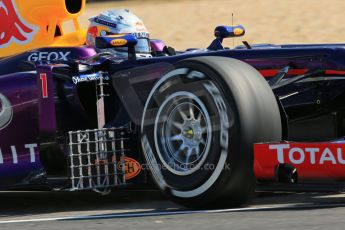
[154,91,212,175]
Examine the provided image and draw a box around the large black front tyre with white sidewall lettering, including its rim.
[141,56,282,207]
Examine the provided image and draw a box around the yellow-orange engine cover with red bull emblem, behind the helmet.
[0,0,86,57]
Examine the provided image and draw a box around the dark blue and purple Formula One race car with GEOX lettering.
[0,0,345,207]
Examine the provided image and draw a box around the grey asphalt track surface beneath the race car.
[0,191,345,230]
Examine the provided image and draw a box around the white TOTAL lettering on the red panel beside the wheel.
[269,144,345,165]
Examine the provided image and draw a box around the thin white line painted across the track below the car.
[0,204,345,224]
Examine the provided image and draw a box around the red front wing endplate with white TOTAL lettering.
[254,142,345,180]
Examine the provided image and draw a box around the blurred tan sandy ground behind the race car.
[80,0,345,49]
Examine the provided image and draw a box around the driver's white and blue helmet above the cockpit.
[86,9,151,57]
